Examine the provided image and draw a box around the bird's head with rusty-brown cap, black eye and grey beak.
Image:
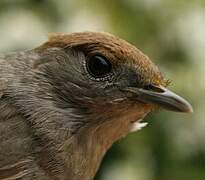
[35,32,192,135]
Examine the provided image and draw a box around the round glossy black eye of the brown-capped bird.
[87,55,112,78]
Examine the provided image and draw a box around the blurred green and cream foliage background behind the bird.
[0,0,205,180]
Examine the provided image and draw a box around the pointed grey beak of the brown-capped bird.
[124,86,193,112]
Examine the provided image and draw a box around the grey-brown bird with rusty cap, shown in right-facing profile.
[0,32,193,180]
